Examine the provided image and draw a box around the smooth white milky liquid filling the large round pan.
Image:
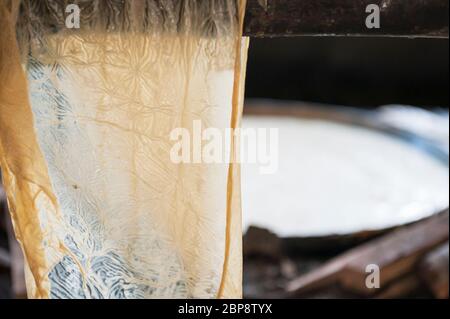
[242,116,449,237]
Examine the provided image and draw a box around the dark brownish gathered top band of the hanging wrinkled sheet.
[12,0,240,37]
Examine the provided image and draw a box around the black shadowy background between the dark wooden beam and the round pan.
[246,37,449,108]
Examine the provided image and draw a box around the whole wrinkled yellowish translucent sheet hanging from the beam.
[0,0,247,298]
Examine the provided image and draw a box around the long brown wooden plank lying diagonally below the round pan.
[287,211,449,296]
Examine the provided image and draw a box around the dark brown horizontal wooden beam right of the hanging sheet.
[244,0,449,38]
